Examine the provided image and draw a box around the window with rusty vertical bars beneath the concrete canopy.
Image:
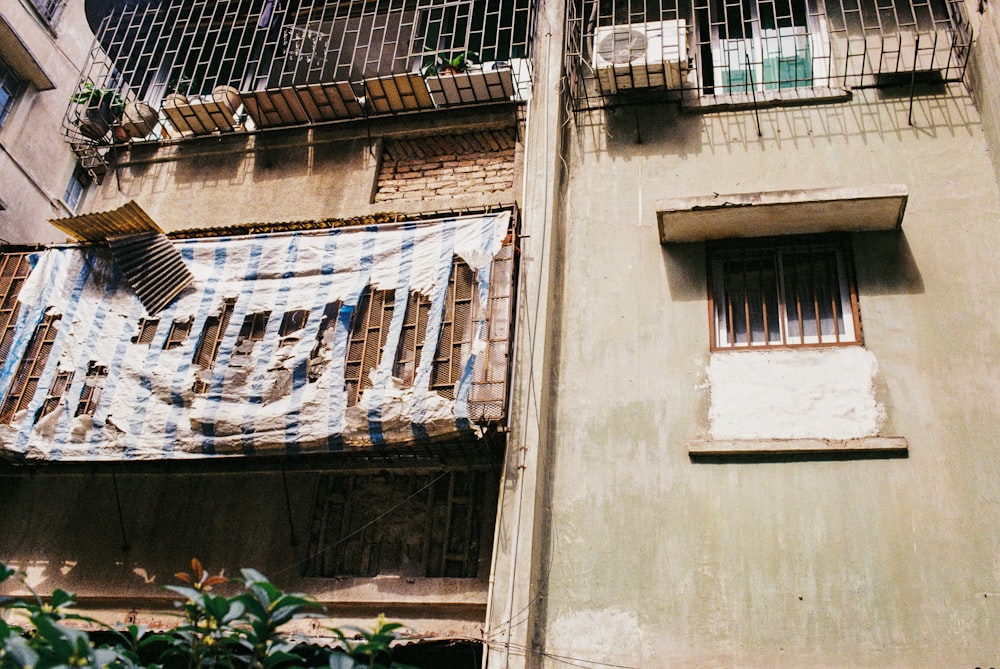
[708,235,862,349]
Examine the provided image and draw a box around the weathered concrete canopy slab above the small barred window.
[656,184,908,244]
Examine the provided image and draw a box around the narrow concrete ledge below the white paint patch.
[688,437,909,457]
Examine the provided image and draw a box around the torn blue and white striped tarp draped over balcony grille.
[0,212,510,460]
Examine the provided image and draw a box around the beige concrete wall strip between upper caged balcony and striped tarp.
[86,107,519,231]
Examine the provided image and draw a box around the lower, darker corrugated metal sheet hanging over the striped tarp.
[108,232,194,316]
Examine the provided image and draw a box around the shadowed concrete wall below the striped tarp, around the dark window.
[0,462,496,638]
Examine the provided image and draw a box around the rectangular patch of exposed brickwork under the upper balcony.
[375,128,517,202]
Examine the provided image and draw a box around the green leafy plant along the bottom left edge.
[0,560,416,669]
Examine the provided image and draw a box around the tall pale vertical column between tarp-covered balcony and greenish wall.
[483,0,568,669]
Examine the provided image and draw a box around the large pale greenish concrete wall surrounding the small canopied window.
[527,85,1000,667]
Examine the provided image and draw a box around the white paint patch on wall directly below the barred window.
[707,346,885,439]
